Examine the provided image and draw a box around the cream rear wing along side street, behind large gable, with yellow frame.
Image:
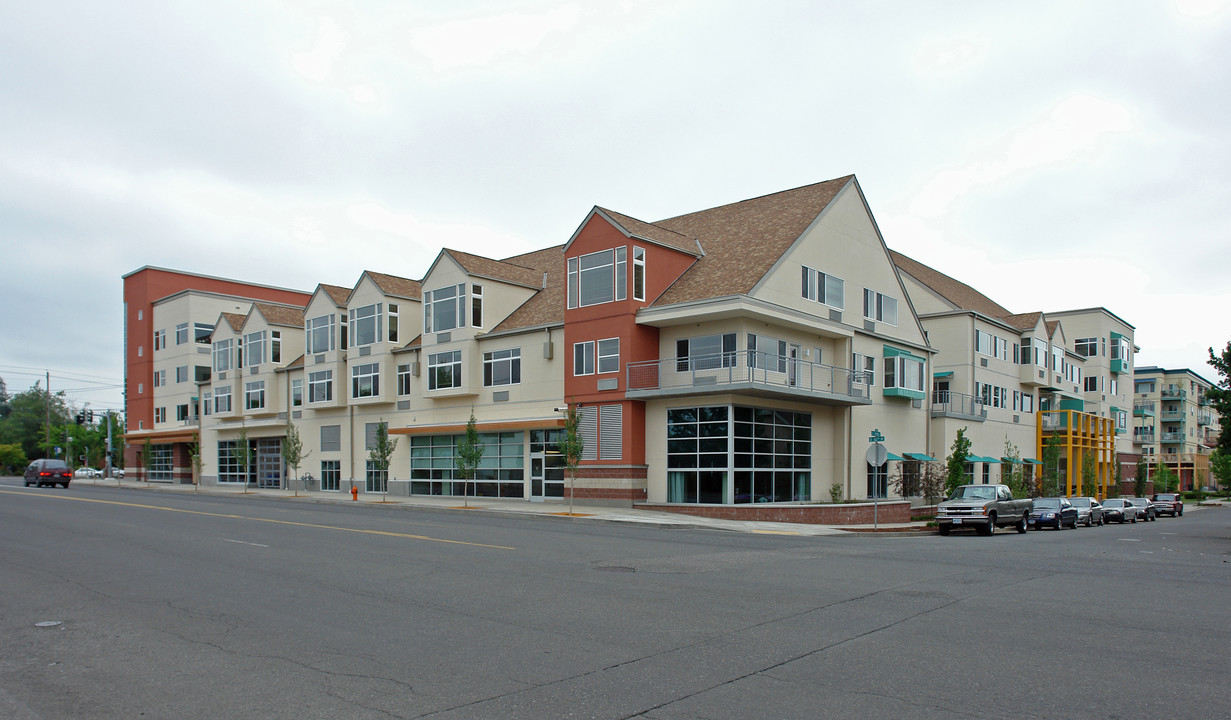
[892,252,1137,492]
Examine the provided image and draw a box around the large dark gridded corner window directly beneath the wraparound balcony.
[667,405,812,503]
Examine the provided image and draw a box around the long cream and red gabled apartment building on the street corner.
[129,176,1181,506]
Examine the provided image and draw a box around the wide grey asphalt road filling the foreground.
[0,480,1231,720]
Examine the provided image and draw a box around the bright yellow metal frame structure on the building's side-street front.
[1035,410,1115,500]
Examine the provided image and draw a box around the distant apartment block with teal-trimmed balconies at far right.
[1133,366,1221,490]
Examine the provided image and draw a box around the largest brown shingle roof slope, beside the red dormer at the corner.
[654,176,854,305]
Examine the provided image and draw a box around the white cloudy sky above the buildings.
[0,0,1231,407]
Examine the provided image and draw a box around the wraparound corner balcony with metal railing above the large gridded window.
[625,352,872,405]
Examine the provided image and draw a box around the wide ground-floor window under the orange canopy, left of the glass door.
[410,432,526,497]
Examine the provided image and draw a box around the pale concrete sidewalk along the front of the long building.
[73,478,927,535]
